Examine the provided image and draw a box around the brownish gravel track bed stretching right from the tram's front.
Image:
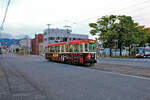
[90,63,150,78]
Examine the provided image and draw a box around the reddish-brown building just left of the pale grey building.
[30,34,43,55]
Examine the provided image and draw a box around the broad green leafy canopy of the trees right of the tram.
[89,15,147,55]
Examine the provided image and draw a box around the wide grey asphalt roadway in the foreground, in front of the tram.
[0,55,150,100]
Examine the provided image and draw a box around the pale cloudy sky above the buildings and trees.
[0,0,150,37]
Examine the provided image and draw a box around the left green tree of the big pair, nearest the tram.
[89,15,117,56]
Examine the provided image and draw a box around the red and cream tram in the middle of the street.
[45,40,96,65]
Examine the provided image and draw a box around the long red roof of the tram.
[46,40,95,47]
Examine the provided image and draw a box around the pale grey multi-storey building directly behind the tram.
[43,28,88,53]
